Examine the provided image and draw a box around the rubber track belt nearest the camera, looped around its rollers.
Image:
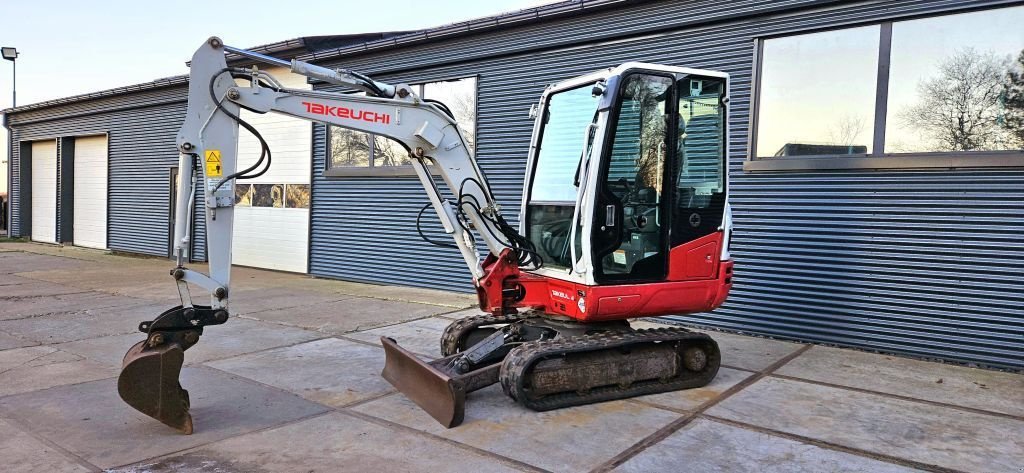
[499,328,721,411]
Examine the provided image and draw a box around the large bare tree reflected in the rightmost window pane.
[899,48,1013,152]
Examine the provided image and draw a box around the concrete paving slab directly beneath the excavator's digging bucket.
[0,368,326,468]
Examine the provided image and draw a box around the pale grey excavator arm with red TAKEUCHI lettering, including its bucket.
[118,37,539,433]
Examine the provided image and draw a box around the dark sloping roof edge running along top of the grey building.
[0,0,610,114]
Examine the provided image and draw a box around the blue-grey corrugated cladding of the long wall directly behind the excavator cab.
[310,0,1024,369]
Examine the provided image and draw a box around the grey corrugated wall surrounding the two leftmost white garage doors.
[10,87,206,261]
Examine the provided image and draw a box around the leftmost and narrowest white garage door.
[32,139,57,243]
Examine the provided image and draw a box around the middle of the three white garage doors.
[74,136,106,250]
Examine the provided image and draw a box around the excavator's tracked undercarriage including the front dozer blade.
[382,312,721,427]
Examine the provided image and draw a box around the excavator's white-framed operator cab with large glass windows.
[520,62,731,286]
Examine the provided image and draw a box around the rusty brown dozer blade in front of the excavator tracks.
[381,337,466,428]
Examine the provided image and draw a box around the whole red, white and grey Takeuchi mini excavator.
[118,38,732,433]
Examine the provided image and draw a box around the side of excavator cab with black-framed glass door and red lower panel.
[591,72,727,284]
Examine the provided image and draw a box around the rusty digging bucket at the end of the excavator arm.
[118,340,193,434]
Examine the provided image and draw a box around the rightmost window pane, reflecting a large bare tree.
[886,7,1024,153]
